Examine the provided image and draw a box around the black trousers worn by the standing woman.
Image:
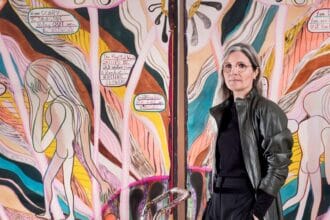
[203,177,255,220]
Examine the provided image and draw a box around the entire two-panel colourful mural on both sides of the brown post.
[0,0,330,220]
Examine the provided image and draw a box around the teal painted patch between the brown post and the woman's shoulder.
[187,72,218,149]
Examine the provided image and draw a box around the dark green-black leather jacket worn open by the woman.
[210,89,293,220]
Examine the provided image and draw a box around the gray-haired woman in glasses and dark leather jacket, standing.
[203,43,292,220]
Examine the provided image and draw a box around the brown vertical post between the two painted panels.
[170,0,187,220]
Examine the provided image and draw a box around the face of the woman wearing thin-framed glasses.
[222,51,258,98]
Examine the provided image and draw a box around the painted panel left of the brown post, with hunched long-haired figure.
[0,0,173,219]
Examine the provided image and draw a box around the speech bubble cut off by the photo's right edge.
[307,8,330,33]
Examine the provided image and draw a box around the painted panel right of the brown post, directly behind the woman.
[186,0,330,220]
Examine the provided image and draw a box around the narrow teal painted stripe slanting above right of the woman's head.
[252,5,278,52]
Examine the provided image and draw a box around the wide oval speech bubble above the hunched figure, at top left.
[28,8,79,35]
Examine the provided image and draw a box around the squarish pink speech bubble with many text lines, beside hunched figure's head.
[100,52,136,87]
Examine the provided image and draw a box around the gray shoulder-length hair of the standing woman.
[221,43,262,95]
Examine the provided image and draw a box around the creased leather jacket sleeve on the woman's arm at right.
[258,101,293,196]
